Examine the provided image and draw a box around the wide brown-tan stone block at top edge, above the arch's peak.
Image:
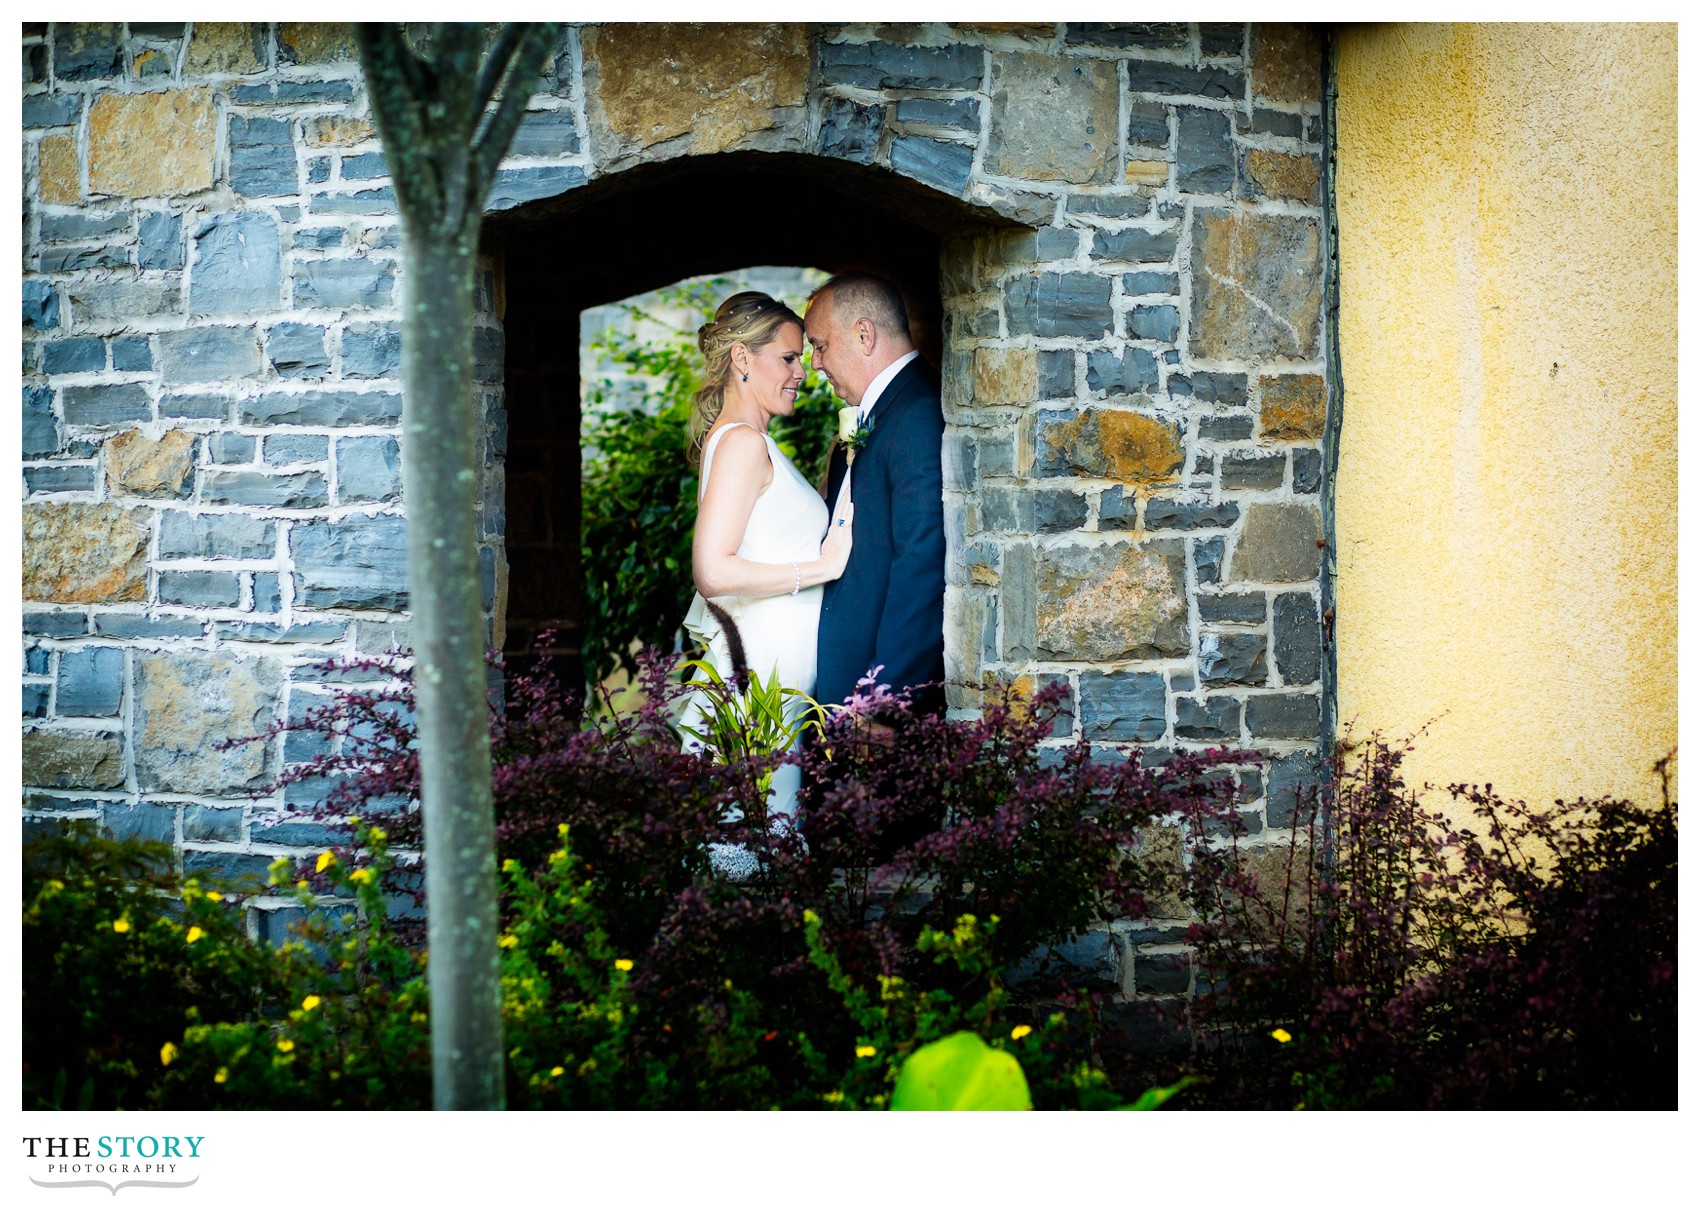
[585,24,809,155]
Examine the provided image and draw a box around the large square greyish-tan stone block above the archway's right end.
[986,51,1120,185]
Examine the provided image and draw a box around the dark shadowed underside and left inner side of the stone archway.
[491,153,1013,686]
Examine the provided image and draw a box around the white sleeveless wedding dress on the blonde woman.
[680,422,828,879]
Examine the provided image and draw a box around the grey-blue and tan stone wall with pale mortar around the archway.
[24,24,1328,996]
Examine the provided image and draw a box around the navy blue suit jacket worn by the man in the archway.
[814,359,945,709]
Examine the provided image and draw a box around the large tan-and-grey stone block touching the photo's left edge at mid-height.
[24,503,148,602]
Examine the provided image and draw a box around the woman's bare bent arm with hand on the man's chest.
[690,428,850,598]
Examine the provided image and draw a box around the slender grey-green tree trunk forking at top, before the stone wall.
[355,24,556,1110]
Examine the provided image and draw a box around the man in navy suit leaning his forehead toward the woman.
[804,272,945,711]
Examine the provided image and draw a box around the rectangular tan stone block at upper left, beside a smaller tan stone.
[88,88,218,197]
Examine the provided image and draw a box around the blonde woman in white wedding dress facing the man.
[680,291,853,877]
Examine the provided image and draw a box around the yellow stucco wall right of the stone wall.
[1335,24,1676,802]
